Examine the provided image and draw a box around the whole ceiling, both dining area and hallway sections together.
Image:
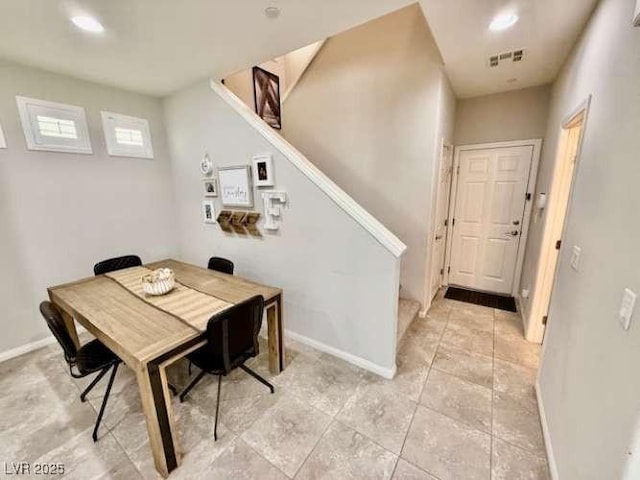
[0,0,597,98]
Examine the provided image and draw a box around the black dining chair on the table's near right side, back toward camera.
[180,295,274,440]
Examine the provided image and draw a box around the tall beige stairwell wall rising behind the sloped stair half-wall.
[282,5,450,301]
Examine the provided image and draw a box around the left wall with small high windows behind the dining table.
[0,62,175,353]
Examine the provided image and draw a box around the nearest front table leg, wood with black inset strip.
[137,363,180,478]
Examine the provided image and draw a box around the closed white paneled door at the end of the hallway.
[449,146,533,294]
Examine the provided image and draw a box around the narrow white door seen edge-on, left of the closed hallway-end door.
[431,144,453,298]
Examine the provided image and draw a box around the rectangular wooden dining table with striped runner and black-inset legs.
[48,259,284,477]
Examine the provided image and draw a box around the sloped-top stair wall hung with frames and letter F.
[165,82,400,375]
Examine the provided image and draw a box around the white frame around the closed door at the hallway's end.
[444,138,542,298]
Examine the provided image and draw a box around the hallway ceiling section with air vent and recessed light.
[420,0,597,98]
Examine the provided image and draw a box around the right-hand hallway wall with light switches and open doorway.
[523,0,640,480]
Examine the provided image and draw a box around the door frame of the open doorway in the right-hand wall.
[524,95,591,343]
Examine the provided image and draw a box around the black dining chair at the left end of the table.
[40,301,122,442]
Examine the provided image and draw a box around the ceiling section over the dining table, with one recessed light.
[0,0,413,96]
